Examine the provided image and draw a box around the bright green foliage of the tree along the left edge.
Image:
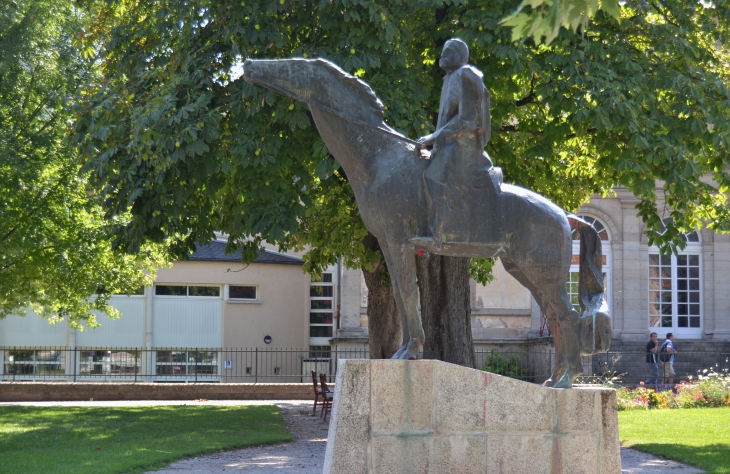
[0,0,166,327]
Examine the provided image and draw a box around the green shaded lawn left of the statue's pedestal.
[0,405,292,474]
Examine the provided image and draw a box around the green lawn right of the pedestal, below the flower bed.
[618,408,730,474]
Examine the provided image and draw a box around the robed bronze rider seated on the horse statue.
[411,39,501,250]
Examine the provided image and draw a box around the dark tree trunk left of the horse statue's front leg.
[362,233,403,359]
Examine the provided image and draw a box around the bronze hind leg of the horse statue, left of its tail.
[500,257,583,388]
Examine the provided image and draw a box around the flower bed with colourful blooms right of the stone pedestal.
[616,369,730,411]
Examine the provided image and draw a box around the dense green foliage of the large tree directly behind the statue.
[75,0,730,278]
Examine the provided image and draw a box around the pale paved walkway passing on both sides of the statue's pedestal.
[0,400,703,474]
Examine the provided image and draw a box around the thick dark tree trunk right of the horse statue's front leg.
[412,255,475,368]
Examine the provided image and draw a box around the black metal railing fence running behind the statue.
[0,345,730,385]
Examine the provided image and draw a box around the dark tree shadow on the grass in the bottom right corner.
[627,443,730,474]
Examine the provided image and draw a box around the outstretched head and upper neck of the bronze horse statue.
[243,58,383,125]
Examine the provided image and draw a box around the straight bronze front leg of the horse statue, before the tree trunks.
[381,244,425,359]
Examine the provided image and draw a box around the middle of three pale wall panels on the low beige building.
[76,296,145,348]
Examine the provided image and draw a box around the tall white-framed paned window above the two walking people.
[649,219,702,337]
